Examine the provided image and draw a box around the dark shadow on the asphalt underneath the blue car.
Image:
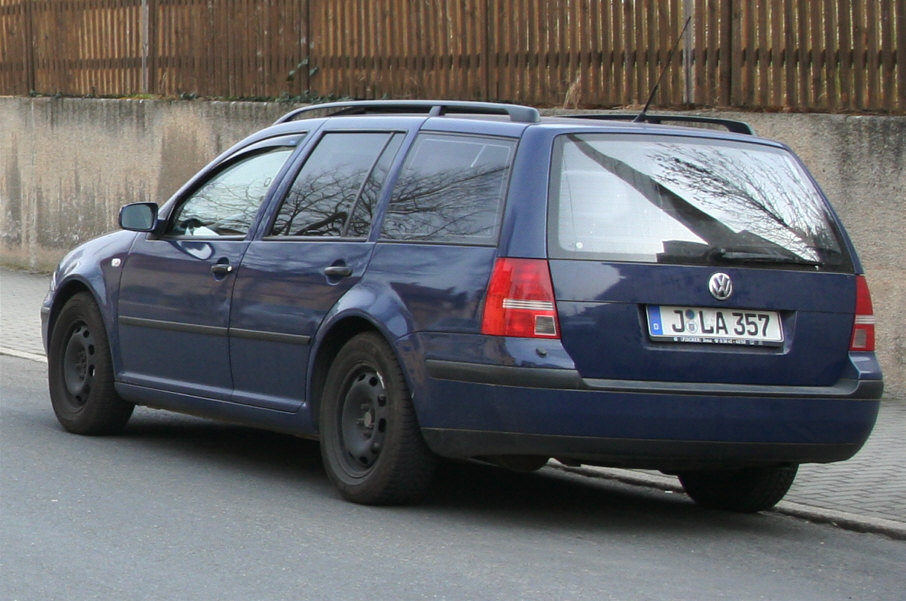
[117,410,789,535]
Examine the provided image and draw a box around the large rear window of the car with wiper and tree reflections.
[549,134,851,270]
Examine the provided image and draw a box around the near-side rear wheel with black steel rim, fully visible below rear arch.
[320,333,436,505]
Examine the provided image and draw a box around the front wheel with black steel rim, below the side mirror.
[47,292,135,434]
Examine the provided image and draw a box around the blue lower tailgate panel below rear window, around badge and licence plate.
[551,260,855,386]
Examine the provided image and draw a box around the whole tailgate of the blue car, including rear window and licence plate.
[549,135,855,386]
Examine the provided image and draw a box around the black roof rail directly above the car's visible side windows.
[274,100,541,125]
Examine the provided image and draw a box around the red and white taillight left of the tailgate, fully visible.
[481,259,560,338]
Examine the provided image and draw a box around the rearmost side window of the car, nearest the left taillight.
[381,133,515,244]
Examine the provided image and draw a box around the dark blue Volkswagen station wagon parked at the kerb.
[42,101,883,511]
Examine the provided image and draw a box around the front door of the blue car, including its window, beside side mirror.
[118,142,298,400]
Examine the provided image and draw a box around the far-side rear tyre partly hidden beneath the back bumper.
[679,465,799,513]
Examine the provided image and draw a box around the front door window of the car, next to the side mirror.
[167,146,293,238]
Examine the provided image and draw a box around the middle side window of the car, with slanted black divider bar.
[270,132,403,238]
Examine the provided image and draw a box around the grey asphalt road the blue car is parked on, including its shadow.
[0,356,906,601]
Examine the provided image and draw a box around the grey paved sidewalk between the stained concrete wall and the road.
[0,269,906,539]
